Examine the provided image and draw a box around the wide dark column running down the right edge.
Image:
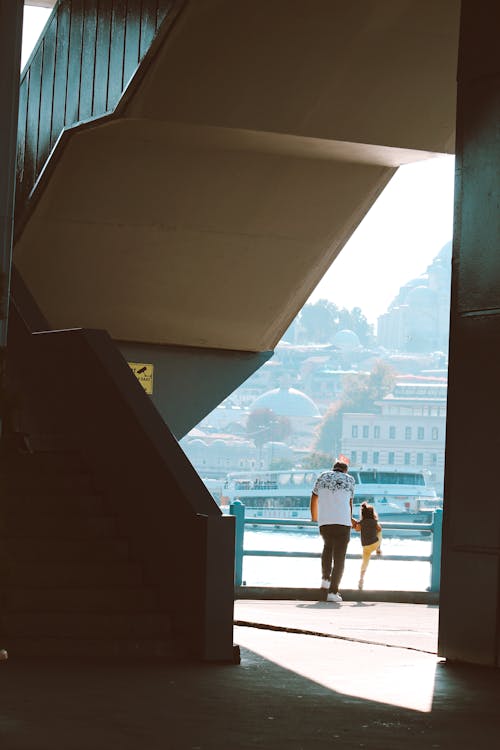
[439,0,500,667]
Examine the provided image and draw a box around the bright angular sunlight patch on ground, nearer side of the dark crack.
[235,627,438,712]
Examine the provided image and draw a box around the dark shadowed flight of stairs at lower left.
[0,450,179,658]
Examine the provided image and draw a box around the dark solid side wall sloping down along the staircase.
[8,273,234,661]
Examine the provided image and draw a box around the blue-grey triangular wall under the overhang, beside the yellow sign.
[117,342,272,440]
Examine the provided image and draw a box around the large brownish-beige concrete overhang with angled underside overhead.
[15,0,459,351]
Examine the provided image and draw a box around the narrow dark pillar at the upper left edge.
[0,0,24,346]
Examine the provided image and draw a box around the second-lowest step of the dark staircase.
[0,612,171,640]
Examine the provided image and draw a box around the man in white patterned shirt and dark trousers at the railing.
[311,461,355,602]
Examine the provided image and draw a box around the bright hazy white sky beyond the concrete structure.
[22,7,454,323]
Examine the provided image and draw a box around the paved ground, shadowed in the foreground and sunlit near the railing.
[0,601,500,750]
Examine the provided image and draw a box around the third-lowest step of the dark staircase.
[0,586,158,614]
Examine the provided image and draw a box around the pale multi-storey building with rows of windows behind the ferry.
[341,382,447,496]
